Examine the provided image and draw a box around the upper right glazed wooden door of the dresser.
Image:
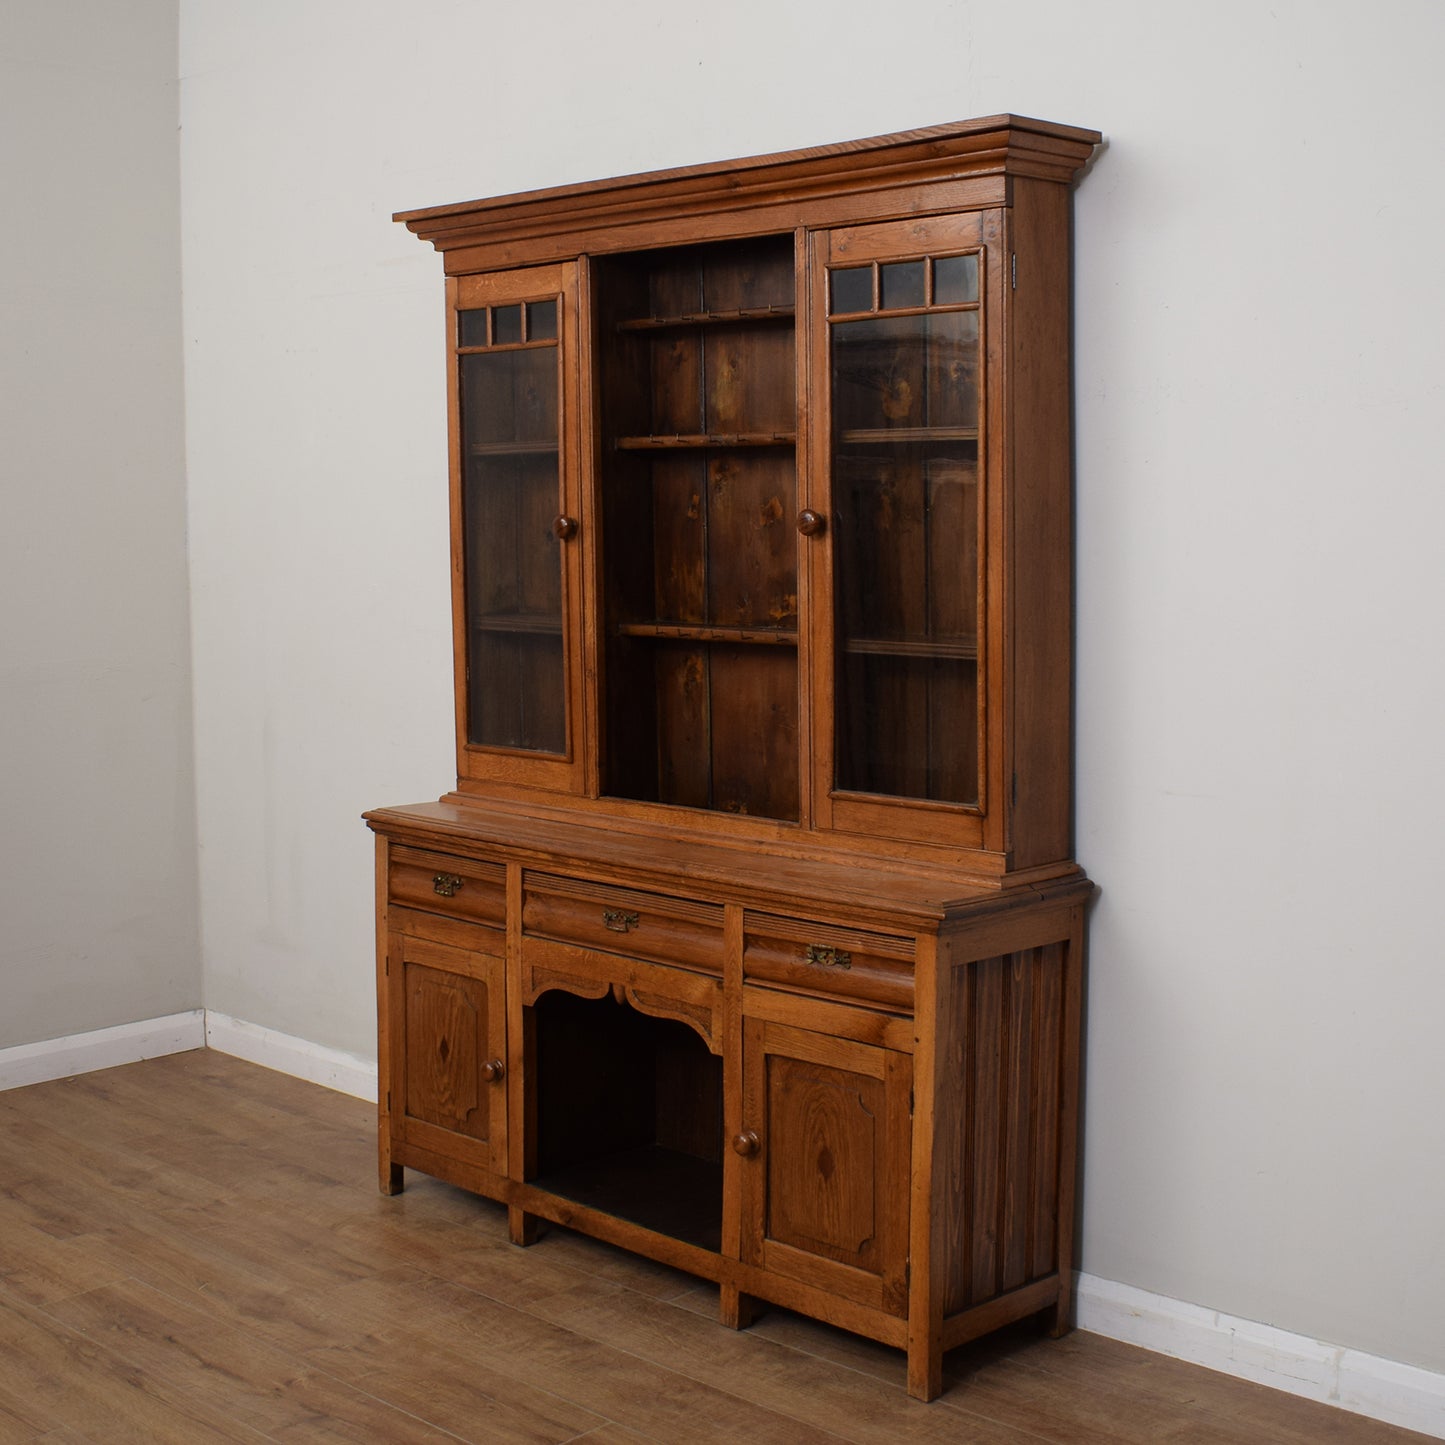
[806,212,998,847]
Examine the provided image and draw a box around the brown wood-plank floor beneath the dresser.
[0,1051,1425,1445]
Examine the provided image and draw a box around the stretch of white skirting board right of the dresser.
[1077,1274,1445,1439]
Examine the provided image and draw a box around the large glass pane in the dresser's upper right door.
[831,307,980,803]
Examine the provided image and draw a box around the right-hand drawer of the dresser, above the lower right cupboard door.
[743,913,913,1013]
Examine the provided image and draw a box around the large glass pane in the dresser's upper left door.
[460,343,566,753]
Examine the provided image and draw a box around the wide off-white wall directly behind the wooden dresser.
[181,0,1445,1370]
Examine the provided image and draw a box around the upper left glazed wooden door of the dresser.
[448,263,587,792]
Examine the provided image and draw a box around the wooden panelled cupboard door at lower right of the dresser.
[734,1019,913,1315]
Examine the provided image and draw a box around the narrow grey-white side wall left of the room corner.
[0,0,201,1048]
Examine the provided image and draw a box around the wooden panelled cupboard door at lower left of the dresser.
[387,933,507,1173]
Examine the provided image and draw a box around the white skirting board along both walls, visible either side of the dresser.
[0,1009,1445,1439]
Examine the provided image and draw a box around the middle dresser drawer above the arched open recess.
[522,873,723,974]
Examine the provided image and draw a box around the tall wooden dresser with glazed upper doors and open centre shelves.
[367,116,1098,1399]
